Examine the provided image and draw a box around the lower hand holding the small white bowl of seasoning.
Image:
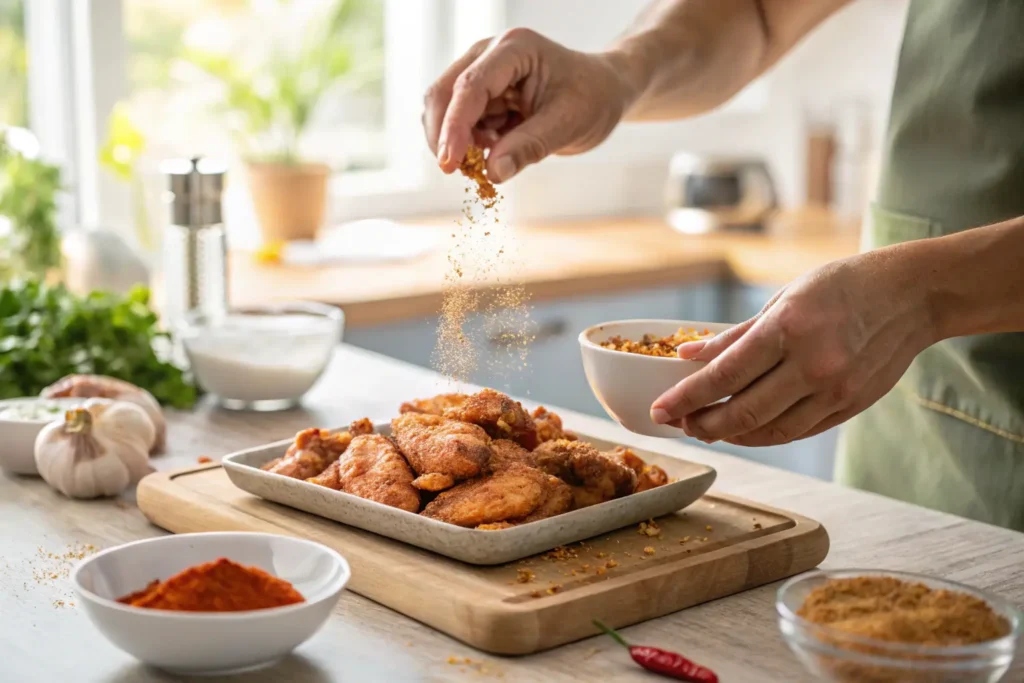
[651,247,937,446]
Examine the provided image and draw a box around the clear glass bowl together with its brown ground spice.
[776,569,1021,683]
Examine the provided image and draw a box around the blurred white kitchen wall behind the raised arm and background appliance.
[493,0,907,220]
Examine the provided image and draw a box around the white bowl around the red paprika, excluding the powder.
[72,531,350,676]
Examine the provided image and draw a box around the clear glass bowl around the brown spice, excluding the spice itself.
[775,569,1021,683]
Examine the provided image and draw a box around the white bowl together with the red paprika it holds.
[72,531,351,676]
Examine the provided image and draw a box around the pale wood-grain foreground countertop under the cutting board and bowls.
[0,347,1024,683]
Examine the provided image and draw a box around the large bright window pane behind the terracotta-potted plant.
[123,0,388,171]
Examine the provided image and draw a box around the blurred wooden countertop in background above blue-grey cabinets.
[230,209,858,327]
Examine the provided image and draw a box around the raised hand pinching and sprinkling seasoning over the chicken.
[423,29,633,182]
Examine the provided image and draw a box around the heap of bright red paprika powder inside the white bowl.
[118,557,305,612]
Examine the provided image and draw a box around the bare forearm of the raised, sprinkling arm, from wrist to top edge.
[607,0,849,121]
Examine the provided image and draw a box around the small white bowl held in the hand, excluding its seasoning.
[580,319,733,438]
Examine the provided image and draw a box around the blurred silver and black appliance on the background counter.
[665,153,777,234]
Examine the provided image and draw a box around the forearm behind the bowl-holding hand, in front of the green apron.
[905,216,1024,340]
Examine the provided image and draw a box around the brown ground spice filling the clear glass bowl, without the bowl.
[797,575,1010,646]
